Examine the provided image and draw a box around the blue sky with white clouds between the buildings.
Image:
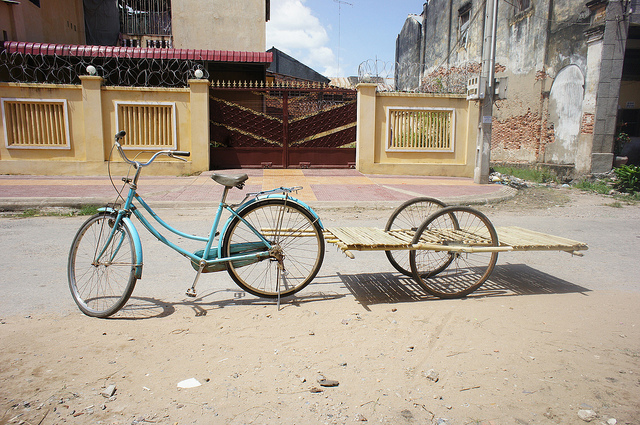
[266,0,424,78]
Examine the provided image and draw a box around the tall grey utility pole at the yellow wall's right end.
[473,0,498,184]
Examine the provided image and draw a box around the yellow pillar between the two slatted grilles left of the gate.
[80,75,105,162]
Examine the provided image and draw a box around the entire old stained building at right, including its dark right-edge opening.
[396,0,640,174]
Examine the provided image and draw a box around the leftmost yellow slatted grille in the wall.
[2,99,70,149]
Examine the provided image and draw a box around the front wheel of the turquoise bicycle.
[67,213,137,317]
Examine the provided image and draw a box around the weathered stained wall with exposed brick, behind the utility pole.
[399,0,640,173]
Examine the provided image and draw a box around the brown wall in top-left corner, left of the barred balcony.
[0,0,86,44]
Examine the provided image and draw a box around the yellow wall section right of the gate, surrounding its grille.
[356,84,479,177]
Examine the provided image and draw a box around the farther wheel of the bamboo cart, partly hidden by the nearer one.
[384,197,451,277]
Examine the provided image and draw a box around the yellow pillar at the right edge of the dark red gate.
[356,83,378,173]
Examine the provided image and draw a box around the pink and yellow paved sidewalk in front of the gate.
[0,169,515,210]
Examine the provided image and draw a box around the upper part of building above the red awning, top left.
[0,0,270,52]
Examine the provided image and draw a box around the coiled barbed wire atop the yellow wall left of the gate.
[0,50,209,87]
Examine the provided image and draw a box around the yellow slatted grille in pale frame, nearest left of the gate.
[116,102,177,150]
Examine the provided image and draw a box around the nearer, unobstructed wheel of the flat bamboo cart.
[409,207,499,298]
